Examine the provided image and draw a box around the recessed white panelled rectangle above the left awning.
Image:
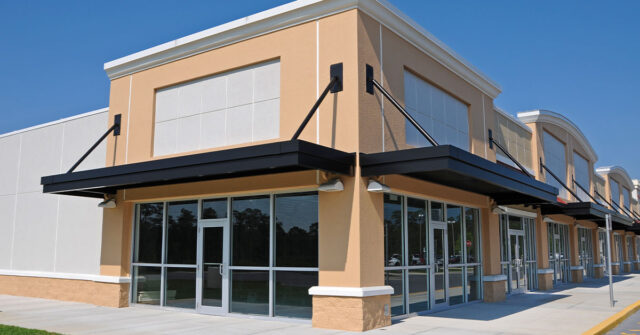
[153,61,280,156]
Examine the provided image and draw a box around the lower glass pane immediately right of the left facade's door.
[230,270,269,315]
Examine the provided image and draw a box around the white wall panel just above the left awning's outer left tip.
[18,124,63,193]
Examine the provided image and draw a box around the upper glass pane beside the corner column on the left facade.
[275,193,318,267]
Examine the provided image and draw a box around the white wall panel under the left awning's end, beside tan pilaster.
[55,196,102,274]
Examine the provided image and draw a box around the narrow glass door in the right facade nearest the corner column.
[431,222,449,309]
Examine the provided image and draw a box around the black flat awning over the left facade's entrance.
[42,140,355,198]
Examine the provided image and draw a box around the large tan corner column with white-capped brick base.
[309,172,392,331]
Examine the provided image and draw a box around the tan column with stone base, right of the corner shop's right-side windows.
[480,208,507,302]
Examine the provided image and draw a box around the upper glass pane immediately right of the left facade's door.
[231,196,271,266]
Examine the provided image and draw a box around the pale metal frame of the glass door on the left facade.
[196,218,231,315]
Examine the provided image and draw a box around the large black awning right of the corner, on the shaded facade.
[360,145,558,205]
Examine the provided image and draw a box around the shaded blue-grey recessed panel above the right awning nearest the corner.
[404,70,469,150]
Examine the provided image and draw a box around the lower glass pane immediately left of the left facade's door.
[164,268,196,308]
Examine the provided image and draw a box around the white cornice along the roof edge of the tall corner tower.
[104,0,501,98]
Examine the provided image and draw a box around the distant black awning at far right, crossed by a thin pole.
[540,202,635,230]
